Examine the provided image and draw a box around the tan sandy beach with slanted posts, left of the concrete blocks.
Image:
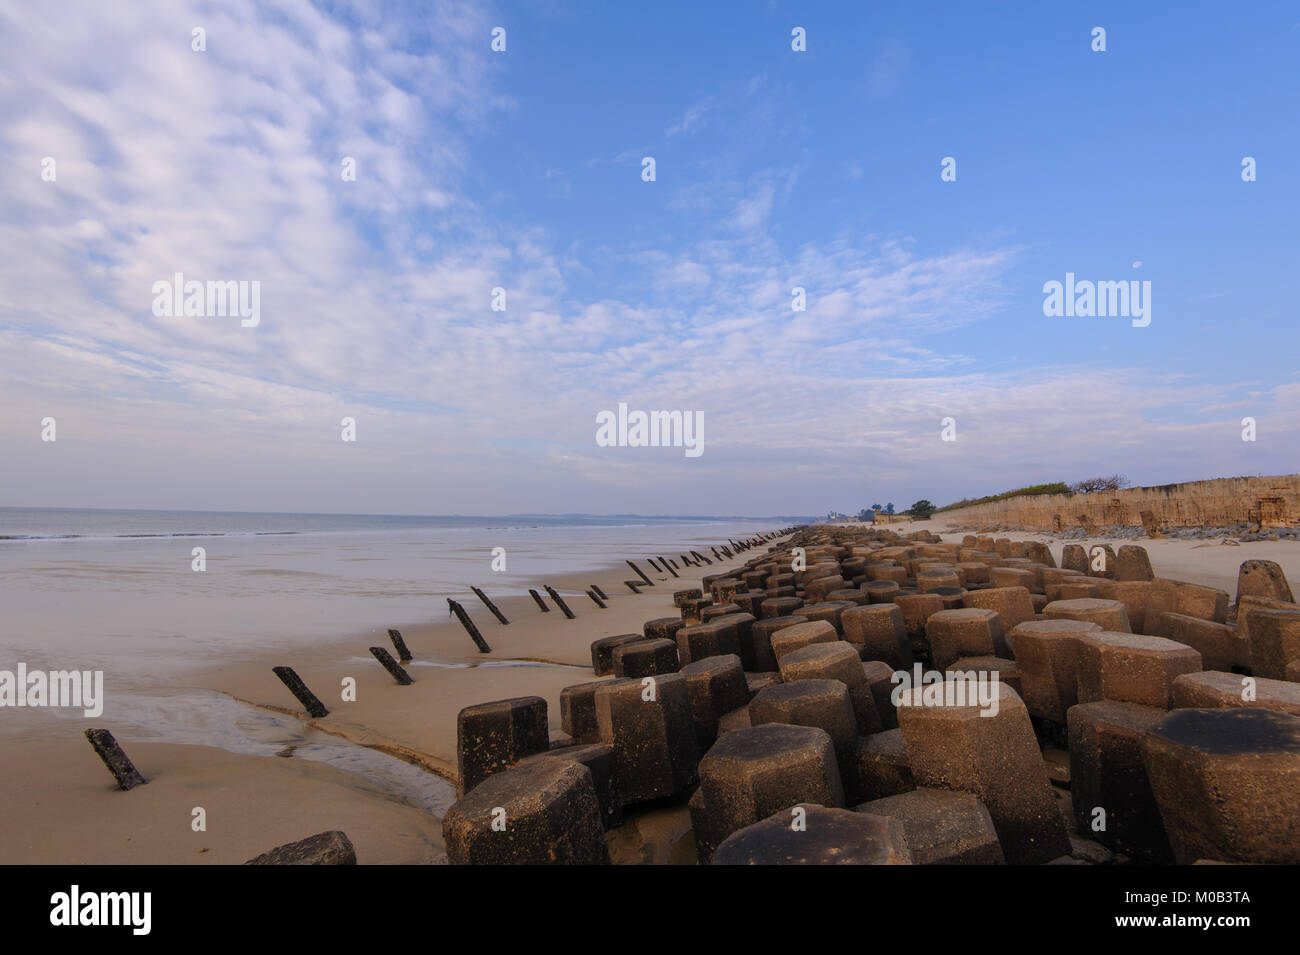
[0,522,769,864]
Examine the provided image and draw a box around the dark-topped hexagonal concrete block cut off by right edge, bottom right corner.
[1143,708,1300,865]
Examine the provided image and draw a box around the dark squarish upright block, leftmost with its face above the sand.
[456,696,551,795]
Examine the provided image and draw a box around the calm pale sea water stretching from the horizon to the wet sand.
[0,508,781,689]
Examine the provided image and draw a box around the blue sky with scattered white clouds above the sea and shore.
[0,0,1300,516]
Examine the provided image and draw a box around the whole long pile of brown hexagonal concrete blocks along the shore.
[445,526,1300,865]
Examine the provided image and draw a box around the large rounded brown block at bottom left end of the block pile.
[442,759,610,865]
